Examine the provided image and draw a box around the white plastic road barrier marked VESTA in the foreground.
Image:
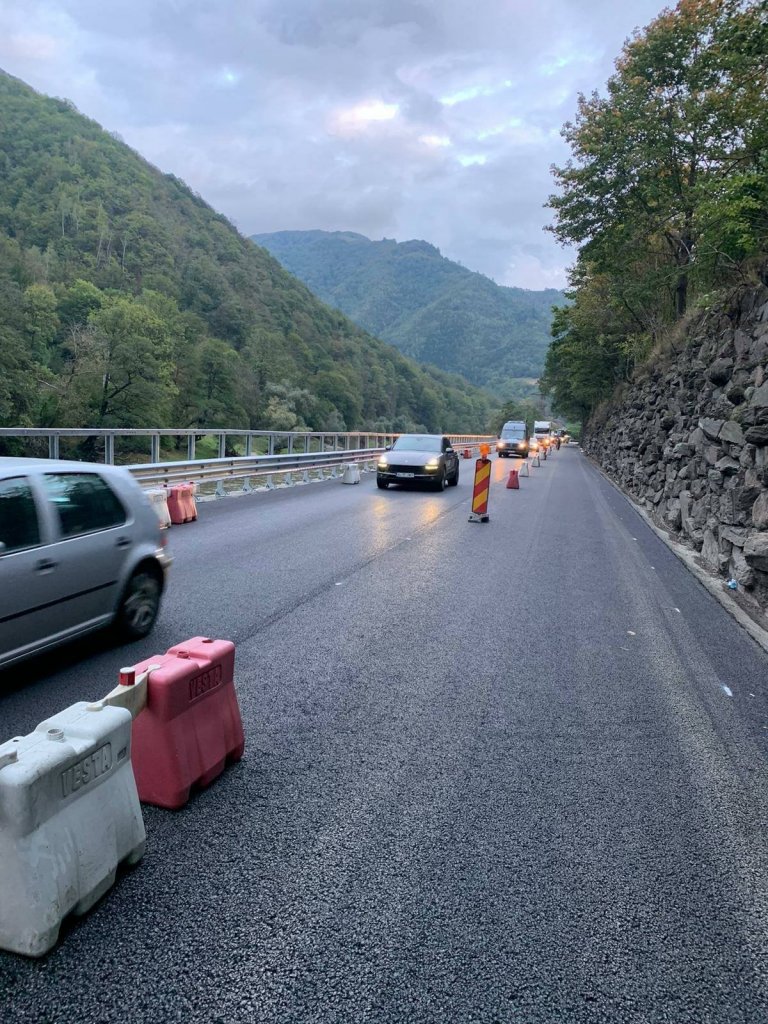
[0,702,145,956]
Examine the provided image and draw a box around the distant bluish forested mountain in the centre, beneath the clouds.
[253,231,563,398]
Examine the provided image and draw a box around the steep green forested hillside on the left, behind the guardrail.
[0,73,493,431]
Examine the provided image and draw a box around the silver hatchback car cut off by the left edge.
[0,458,171,668]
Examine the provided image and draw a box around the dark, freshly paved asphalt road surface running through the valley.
[0,449,768,1024]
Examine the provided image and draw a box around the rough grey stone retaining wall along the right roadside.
[584,288,768,610]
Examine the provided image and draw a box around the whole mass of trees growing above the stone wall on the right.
[543,0,768,415]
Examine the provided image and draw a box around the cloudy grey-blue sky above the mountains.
[0,0,665,288]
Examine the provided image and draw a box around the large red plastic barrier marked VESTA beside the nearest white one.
[131,637,245,810]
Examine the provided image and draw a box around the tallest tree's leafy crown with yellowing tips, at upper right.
[550,0,768,316]
